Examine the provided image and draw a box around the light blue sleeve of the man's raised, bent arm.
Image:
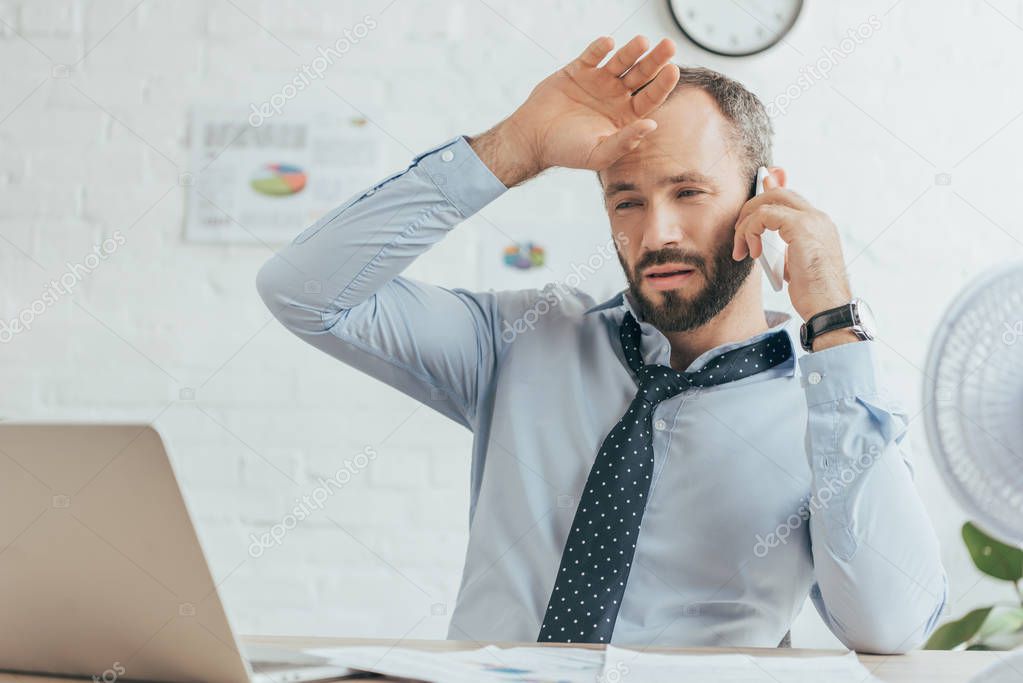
[256,135,507,428]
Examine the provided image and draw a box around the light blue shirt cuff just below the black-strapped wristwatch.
[799,339,881,406]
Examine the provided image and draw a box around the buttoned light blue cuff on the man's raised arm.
[414,135,508,218]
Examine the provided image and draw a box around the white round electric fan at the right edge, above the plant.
[924,263,1023,683]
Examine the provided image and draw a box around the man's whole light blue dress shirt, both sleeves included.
[257,136,947,653]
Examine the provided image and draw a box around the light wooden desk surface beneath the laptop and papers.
[0,636,999,683]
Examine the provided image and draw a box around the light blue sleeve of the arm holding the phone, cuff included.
[799,340,948,654]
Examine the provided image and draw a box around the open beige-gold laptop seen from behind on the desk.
[0,423,353,683]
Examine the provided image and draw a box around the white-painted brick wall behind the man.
[0,0,1023,646]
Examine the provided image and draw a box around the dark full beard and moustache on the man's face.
[616,226,753,332]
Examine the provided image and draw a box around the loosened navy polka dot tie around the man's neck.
[537,312,792,643]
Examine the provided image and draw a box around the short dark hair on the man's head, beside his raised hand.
[633,64,774,187]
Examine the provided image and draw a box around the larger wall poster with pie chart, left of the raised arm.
[183,106,384,243]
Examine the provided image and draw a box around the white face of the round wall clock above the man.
[668,0,803,57]
